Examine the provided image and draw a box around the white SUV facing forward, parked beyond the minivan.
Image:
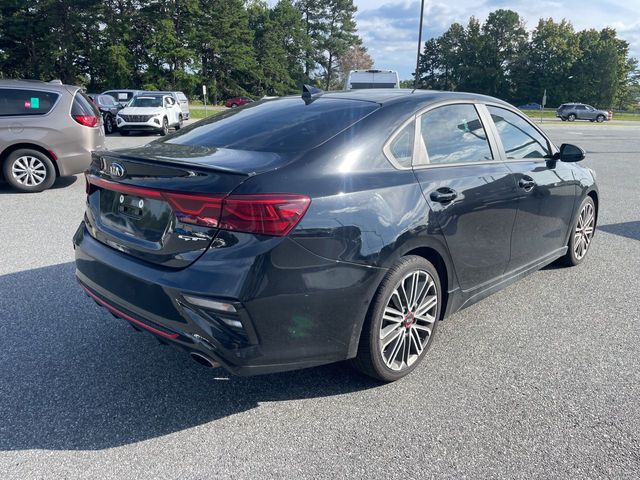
[116,93,183,136]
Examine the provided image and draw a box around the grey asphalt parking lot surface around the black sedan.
[0,123,640,479]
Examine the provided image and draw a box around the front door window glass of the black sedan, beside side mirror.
[487,106,549,160]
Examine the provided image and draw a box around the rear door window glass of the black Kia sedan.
[420,104,493,164]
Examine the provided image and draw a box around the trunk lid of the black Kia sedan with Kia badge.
[85,147,271,268]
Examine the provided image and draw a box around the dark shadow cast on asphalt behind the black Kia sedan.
[0,262,379,451]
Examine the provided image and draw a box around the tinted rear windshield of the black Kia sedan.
[161,98,379,152]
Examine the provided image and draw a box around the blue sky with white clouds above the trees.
[355,0,640,79]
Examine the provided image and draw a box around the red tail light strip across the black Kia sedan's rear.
[86,175,311,236]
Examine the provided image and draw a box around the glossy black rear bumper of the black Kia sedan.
[74,224,385,375]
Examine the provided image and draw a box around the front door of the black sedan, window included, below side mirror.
[487,105,576,271]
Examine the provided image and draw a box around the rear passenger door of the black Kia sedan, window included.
[414,103,518,291]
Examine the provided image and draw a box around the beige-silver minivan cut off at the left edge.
[0,80,105,192]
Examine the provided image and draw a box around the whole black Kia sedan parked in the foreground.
[74,89,598,381]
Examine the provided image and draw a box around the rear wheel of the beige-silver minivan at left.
[2,148,56,193]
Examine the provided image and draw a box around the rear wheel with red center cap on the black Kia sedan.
[352,255,442,382]
